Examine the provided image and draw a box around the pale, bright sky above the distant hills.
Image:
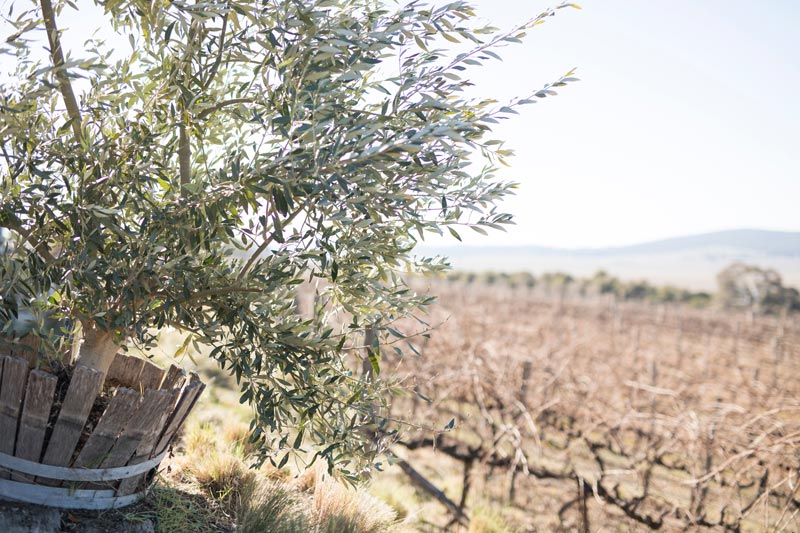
[0,0,800,248]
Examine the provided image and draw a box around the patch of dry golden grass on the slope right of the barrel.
[154,396,396,533]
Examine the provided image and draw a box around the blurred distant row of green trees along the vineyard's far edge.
[448,263,800,314]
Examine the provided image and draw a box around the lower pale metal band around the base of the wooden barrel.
[0,479,147,510]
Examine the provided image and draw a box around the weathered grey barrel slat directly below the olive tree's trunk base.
[42,366,104,484]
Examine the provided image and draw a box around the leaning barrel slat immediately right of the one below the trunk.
[72,387,142,468]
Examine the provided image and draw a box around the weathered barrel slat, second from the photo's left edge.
[11,370,58,481]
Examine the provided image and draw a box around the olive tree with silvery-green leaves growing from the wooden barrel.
[0,0,577,471]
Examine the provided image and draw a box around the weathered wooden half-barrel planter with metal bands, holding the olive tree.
[0,353,205,509]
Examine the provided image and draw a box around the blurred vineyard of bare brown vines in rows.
[376,281,800,532]
